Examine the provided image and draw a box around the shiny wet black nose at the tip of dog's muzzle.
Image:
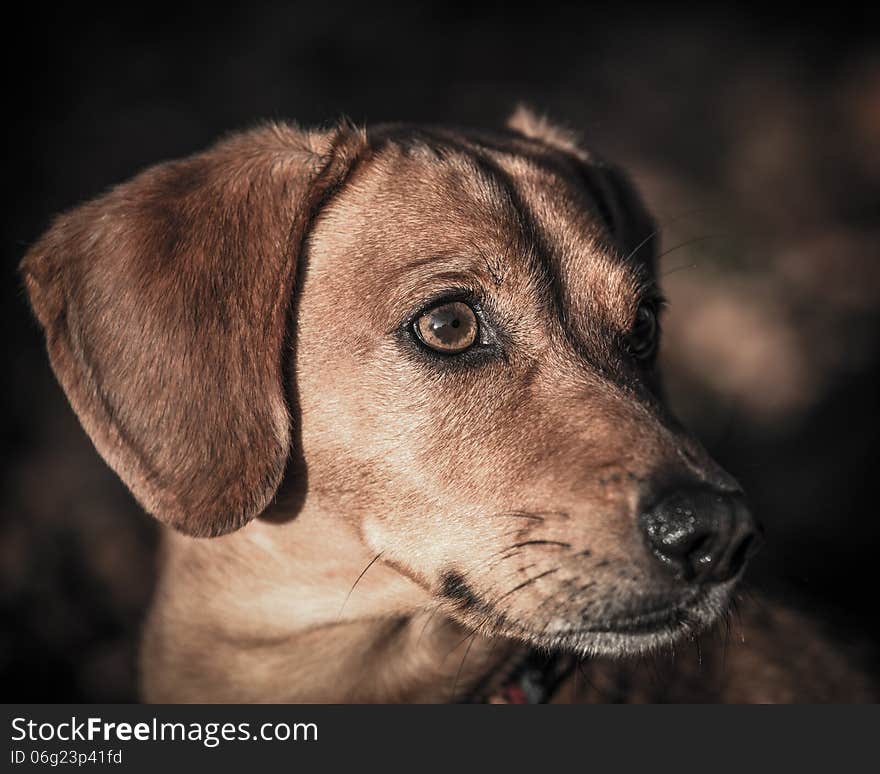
[639,487,760,583]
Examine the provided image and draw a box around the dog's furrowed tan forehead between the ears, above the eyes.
[312,130,643,328]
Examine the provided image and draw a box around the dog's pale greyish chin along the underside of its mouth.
[521,583,734,657]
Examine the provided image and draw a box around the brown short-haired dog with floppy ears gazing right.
[23,111,872,701]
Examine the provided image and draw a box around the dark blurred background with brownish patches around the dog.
[0,2,880,701]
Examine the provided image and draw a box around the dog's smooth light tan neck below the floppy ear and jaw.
[143,512,518,702]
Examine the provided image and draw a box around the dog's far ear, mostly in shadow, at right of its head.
[507,105,659,268]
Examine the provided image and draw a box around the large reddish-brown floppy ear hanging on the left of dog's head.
[21,125,364,536]
